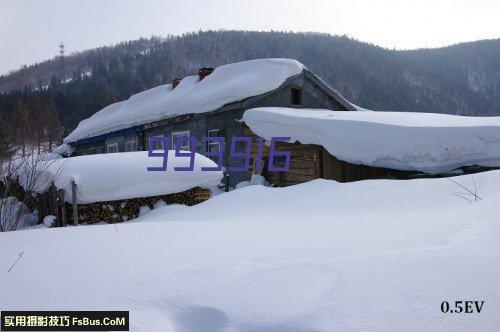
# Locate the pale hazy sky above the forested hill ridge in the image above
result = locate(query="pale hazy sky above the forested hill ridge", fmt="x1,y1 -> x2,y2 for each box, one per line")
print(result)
0,0 -> 500,74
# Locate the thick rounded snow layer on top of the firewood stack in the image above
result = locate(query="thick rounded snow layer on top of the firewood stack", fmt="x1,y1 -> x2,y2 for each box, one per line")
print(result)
11,150 -> 222,204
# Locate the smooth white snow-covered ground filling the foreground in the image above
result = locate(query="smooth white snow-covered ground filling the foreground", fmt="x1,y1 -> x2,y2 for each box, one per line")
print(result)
0,171 -> 500,332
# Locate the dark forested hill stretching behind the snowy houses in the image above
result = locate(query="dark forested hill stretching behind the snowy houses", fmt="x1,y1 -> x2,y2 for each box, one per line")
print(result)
0,31 -> 500,134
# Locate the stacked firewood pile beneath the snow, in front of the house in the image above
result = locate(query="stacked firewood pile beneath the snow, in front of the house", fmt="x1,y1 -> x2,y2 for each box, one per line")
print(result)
65,187 -> 212,224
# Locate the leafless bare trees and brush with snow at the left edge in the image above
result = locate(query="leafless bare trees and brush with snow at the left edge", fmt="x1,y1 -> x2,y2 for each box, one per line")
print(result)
0,102 -> 65,232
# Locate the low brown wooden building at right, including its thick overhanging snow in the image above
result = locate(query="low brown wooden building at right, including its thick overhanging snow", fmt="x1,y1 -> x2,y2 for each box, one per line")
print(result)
243,106 -> 500,186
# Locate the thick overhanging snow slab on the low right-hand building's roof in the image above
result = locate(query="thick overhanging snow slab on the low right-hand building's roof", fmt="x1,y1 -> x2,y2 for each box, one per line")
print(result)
243,107 -> 500,174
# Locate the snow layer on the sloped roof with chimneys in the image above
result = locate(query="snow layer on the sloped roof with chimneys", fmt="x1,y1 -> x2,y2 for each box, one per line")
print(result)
64,59 -> 305,143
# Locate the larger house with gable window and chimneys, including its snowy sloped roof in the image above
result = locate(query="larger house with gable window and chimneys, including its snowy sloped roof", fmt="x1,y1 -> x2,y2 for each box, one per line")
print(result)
64,59 -> 355,186
